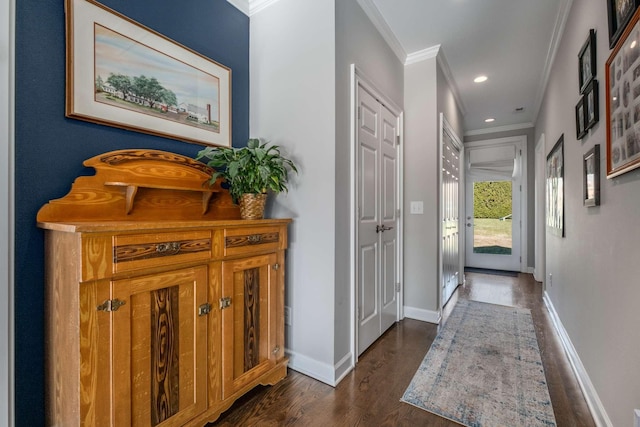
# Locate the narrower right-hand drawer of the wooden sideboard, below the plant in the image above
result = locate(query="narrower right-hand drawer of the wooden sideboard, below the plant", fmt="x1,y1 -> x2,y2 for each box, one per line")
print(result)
224,227 -> 284,256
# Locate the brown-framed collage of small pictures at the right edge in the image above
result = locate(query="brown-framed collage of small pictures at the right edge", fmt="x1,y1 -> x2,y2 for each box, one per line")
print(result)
605,9 -> 640,178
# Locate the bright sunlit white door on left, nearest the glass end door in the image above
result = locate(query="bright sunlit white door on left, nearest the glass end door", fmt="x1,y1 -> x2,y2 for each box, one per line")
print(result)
440,118 -> 461,306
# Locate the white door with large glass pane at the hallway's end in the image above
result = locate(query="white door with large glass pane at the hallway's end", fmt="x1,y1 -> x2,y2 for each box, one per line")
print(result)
465,140 -> 522,271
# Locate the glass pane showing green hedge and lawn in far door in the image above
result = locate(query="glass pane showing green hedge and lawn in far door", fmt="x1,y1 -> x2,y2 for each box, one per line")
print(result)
473,181 -> 512,255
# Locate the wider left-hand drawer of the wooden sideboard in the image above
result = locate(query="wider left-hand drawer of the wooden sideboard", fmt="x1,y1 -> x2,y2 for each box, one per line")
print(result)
113,231 -> 211,273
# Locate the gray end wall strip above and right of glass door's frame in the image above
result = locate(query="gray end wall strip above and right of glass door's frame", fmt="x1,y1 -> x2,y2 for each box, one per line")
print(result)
464,127 -> 538,268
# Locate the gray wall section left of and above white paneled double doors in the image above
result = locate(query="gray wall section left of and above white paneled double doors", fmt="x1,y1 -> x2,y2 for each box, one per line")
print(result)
334,0 -> 404,363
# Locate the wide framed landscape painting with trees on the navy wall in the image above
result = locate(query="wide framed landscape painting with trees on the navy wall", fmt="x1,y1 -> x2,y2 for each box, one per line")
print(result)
65,0 -> 231,147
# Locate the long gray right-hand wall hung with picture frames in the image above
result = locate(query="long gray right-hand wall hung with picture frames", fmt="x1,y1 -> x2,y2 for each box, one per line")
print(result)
535,0 -> 640,426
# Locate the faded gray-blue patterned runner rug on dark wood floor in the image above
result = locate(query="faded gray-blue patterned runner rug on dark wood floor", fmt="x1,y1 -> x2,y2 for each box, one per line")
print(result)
401,300 -> 556,427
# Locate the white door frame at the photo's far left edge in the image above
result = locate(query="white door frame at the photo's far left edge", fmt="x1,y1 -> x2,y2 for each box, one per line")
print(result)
0,0 -> 15,426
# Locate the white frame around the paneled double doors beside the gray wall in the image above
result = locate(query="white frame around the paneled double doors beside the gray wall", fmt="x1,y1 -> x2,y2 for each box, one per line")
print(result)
350,64 -> 404,367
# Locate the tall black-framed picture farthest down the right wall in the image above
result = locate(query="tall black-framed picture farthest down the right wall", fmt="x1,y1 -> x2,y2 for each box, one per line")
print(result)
546,134 -> 565,237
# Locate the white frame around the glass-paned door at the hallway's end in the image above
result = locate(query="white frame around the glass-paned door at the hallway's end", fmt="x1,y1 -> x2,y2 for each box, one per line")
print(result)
464,135 -> 530,273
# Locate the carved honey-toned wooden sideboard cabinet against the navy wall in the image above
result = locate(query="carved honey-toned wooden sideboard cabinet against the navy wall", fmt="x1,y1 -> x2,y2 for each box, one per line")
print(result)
38,150 -> 290,427
